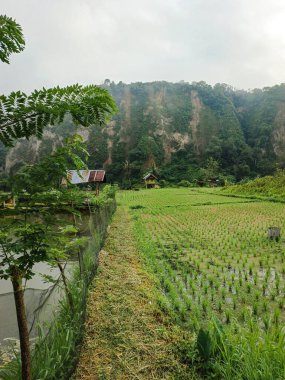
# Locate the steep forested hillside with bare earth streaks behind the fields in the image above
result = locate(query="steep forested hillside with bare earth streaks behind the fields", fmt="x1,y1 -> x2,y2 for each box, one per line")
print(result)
0,80 -> 285,187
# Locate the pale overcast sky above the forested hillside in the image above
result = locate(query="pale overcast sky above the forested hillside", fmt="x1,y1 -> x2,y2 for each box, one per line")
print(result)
0,0 -> 285,94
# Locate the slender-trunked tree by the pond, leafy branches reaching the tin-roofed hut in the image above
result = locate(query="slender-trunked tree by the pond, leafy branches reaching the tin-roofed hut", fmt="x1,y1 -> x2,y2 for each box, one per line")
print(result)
0,136 -> 93,380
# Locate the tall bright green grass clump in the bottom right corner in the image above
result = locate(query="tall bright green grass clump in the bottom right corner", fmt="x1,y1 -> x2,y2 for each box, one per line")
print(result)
202,318 -> 285,380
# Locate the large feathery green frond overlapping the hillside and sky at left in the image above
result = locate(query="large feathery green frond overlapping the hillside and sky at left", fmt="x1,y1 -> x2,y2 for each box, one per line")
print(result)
0,84 -> 116,145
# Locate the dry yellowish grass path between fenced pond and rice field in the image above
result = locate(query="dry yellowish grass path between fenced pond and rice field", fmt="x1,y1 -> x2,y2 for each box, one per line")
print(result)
73,206 -> 191,380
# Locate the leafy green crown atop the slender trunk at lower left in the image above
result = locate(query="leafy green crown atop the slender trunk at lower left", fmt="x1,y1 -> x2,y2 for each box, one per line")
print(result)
0,210 -> 81,281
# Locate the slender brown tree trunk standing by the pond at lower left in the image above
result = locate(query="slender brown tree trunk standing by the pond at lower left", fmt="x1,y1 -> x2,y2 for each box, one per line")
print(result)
11,276 -> 31,380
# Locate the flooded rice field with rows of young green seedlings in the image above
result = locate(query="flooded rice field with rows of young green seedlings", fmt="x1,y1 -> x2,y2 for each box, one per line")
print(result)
118,189 -> 285,379
